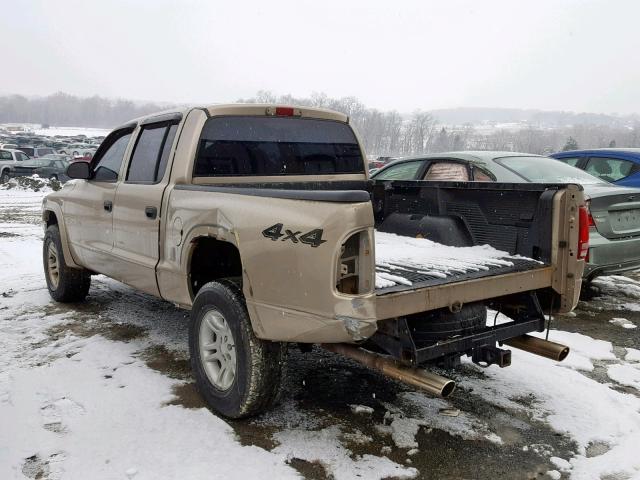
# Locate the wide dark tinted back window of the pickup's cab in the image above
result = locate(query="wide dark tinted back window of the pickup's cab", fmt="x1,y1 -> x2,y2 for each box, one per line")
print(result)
194,117 -> 364,177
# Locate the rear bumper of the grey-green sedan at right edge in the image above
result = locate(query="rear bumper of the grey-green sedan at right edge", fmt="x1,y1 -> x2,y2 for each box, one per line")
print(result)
584,232 -> 640,280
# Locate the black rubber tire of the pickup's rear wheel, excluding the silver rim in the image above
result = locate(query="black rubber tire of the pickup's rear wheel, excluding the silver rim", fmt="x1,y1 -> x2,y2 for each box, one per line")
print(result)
189,279 -> 286,418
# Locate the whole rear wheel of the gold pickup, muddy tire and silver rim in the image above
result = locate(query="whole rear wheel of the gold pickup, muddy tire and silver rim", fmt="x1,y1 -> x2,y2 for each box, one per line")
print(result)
189,280 -> 286,418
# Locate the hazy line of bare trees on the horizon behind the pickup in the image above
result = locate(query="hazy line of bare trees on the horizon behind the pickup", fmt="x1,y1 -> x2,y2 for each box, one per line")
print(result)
0,91 -> 640,156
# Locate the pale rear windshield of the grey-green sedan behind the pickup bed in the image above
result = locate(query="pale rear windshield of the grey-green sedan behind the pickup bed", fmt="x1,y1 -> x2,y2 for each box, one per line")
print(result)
496,157 -> 605,185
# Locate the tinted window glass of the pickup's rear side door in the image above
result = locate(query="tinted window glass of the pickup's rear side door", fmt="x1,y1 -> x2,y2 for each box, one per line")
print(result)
127,124 -> 178,183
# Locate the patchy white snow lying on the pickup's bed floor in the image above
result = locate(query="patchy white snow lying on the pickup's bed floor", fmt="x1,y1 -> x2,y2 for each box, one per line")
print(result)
375,231 -> 542,293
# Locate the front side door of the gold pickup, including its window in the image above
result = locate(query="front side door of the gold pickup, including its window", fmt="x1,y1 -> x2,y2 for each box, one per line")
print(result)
63,126 -> 133,272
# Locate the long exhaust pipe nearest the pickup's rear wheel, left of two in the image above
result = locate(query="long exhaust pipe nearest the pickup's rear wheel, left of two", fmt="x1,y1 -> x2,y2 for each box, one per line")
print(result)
322,343 -> 456,397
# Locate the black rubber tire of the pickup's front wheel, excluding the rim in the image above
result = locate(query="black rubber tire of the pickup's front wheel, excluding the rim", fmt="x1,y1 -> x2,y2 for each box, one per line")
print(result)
42,225 -> 91,303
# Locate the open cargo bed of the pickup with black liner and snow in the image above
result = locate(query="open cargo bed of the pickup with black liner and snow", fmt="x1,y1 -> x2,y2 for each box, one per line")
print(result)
373,181 -> 564,319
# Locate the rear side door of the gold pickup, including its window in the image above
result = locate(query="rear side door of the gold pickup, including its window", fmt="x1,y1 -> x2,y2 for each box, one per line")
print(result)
113,115 -> 181,295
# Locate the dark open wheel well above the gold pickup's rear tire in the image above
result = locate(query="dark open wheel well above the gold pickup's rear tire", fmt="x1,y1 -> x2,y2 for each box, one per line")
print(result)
189,237 -> 242,297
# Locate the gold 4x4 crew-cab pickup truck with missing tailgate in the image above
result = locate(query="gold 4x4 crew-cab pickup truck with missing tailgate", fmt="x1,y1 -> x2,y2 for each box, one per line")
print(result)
43,104 -> 588,418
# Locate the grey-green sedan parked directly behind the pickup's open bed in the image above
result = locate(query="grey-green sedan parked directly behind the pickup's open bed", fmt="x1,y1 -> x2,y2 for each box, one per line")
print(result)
371,152 -> 640,281
